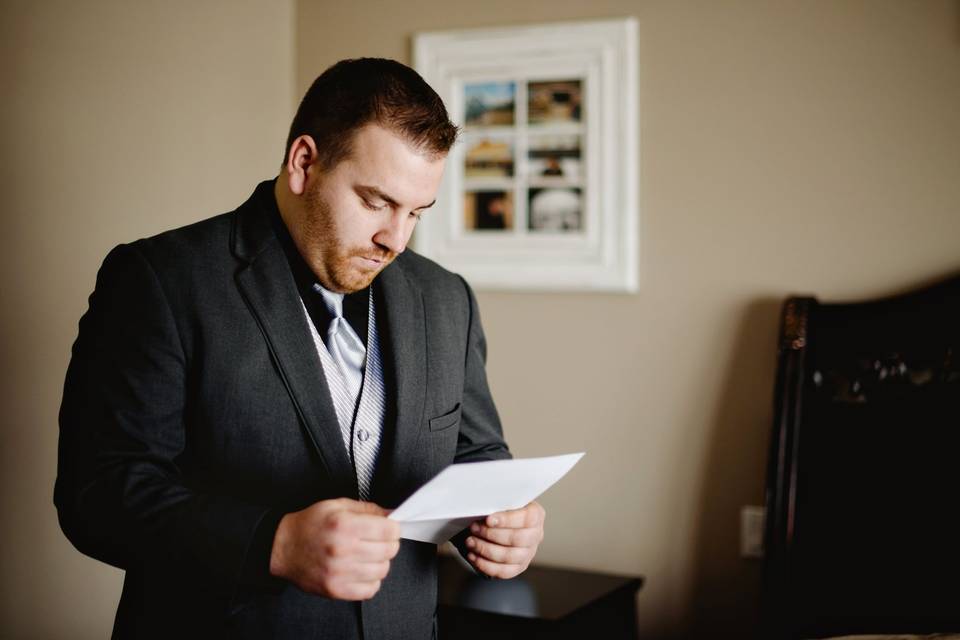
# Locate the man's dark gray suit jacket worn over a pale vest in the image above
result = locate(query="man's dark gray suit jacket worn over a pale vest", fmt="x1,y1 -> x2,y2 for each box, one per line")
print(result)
55,182 -> 510,640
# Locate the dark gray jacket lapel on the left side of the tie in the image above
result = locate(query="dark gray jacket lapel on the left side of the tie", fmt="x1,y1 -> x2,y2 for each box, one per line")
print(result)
233,188 -> 357,498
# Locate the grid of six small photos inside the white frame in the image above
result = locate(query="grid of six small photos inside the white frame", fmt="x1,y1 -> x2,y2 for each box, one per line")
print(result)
462,79 -> 586,233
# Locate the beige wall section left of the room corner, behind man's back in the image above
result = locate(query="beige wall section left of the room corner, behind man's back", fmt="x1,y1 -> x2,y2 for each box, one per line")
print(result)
0,0 -> 294,639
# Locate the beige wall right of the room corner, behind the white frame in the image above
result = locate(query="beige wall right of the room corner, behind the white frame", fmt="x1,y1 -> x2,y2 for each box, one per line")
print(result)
297,0 -> 960,637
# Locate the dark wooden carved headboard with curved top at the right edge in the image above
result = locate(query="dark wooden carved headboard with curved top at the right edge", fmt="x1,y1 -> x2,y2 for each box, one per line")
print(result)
763,277 -> 960,639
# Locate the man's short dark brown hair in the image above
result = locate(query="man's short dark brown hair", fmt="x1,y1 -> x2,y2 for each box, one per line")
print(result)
284,58 -> 457,170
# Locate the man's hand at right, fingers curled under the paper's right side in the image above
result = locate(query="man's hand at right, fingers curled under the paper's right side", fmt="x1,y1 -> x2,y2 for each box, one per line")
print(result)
467,502 -> 547,578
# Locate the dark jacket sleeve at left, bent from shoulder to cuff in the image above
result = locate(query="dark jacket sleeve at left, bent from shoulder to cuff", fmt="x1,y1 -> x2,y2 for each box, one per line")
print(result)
54,244 -> 278,591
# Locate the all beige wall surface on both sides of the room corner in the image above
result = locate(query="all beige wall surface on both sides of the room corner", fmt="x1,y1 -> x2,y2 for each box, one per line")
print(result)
0,0 -> 960,638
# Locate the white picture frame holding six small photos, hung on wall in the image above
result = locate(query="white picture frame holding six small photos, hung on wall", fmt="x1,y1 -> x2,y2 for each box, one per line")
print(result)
414,19 -> 640,292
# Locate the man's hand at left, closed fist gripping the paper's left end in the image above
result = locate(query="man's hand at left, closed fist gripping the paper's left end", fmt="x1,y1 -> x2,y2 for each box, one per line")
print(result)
270,498 -> 400,600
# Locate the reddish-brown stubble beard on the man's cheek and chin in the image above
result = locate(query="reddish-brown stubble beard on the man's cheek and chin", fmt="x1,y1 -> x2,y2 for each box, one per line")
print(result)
303,182 -> 397,293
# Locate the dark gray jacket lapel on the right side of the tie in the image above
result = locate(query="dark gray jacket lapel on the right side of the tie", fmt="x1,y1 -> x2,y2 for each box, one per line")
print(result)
372,261 -> 427,506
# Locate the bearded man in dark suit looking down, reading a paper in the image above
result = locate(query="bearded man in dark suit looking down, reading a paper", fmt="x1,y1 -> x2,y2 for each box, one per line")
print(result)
55,59 -> 544,640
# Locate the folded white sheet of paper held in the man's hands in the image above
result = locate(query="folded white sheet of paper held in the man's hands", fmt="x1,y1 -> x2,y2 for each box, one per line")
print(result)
390,453 -> 583,544
